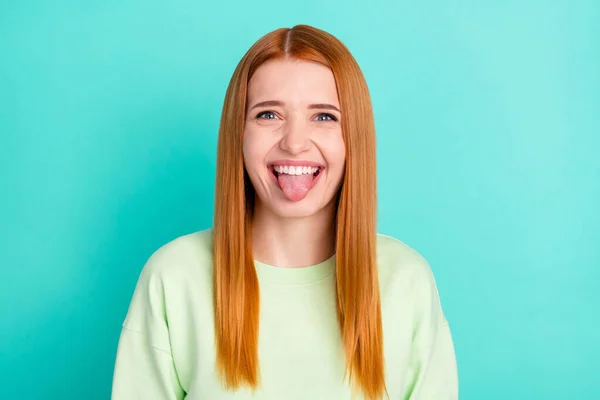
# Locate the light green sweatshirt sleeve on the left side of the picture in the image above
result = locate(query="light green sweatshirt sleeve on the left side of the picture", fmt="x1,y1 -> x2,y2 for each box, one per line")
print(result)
112,253 -> 184,400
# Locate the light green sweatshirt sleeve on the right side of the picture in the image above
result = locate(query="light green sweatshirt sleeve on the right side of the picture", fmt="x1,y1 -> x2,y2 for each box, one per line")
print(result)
403,260 -> 458,400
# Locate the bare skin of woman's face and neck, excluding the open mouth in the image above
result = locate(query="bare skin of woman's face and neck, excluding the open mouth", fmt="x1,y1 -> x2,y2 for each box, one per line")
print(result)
243,60 -> 345,268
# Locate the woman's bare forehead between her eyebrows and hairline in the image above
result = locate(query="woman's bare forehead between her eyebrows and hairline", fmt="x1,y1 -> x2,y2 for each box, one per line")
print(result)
248,60 -> 339,106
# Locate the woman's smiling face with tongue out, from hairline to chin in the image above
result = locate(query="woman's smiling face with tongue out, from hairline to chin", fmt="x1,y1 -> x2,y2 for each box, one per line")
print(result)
243,60 -> 345,217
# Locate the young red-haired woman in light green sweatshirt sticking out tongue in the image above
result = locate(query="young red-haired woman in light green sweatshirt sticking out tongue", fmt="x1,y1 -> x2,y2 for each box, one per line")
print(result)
113,25 -> 458,400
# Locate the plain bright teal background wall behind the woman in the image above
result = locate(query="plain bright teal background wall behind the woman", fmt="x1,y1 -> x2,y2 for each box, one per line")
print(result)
0,0 -> 600,400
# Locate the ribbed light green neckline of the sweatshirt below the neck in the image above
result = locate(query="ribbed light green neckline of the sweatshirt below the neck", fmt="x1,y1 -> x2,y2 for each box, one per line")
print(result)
254,254 -> 335,285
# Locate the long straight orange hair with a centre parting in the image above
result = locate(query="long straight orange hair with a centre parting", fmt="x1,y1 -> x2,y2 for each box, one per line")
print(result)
213,25 -> 387,399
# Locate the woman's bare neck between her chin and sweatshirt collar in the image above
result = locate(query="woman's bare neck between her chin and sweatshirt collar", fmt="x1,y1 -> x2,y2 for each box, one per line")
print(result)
252,201 -> 336,268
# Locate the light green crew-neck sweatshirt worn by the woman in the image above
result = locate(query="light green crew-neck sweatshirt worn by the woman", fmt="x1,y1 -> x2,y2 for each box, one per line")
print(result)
112,229 -> 458,400
